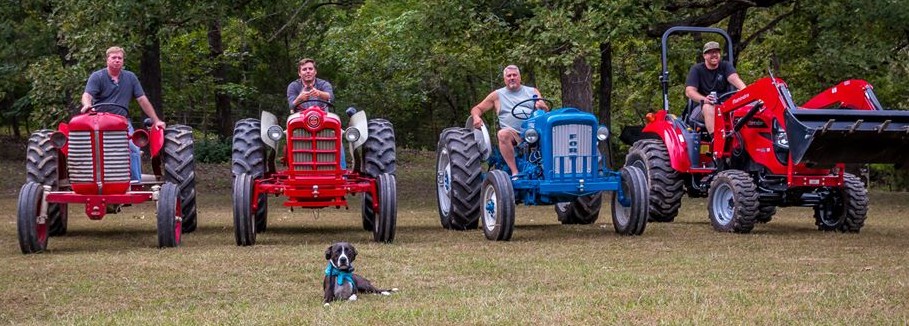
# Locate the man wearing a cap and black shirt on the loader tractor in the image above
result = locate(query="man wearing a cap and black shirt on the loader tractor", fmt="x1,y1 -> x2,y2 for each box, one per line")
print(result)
685,41 -> 745,133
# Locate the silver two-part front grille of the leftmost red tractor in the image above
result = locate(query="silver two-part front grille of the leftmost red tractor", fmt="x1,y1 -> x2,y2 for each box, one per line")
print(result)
66,131 -> 129,183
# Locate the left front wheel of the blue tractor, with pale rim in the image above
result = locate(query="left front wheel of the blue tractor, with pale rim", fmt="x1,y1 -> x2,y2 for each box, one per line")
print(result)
482,170 -> 514,241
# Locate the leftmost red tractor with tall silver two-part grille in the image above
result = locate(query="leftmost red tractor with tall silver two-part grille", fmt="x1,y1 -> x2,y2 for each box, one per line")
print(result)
17,103 -> 196,254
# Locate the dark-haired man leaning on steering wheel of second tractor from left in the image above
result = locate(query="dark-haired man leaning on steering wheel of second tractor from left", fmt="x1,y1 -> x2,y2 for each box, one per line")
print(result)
287,58 -> 335,113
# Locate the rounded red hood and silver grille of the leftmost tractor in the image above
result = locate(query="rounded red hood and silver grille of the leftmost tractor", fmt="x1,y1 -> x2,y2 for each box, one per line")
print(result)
61,113 -> 148,195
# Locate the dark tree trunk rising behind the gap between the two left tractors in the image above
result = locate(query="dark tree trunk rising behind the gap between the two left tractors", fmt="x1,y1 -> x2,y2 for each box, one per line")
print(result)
208,19 -> 233,139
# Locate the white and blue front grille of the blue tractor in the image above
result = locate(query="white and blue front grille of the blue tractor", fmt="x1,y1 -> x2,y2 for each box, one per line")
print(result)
552,124 -> 597,178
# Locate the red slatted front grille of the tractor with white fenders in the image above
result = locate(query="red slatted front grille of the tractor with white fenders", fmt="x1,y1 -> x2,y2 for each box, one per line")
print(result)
291,128 -> 338,171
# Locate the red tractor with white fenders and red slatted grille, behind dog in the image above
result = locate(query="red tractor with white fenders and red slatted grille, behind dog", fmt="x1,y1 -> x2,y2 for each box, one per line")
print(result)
231,100 -> 397,246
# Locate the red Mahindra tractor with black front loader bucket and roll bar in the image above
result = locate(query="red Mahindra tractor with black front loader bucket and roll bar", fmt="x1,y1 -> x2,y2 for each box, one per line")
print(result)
625,27 -> 909,233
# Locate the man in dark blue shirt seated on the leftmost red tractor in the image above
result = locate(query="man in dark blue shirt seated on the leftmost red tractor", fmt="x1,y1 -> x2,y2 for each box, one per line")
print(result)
81,46 -> 166,181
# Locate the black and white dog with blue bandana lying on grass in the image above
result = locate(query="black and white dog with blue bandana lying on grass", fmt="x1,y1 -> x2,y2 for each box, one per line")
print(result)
322,242 -> 398,306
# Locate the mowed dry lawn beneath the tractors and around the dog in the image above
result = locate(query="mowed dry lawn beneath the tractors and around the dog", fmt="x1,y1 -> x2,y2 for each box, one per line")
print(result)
0,151 -> 909,325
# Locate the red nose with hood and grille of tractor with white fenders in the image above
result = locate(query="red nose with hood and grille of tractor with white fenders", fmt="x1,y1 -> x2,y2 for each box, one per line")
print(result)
286,109 -> 342,174
